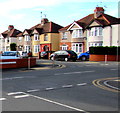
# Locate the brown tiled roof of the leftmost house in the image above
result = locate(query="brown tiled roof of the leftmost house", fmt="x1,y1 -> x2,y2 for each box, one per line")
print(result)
1,29 -> 21,38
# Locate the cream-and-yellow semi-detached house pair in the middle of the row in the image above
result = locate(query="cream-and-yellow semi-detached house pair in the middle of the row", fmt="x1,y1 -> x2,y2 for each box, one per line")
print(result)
18,18 -> 62,56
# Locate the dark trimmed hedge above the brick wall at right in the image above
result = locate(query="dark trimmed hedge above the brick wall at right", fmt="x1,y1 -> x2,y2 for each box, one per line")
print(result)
89,46 -> 120,55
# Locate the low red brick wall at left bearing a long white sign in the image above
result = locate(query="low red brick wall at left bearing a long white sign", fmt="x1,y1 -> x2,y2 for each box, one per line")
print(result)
0,58 -> 36,69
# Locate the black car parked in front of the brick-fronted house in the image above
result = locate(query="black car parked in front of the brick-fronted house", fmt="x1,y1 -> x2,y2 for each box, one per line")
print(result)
50,50 -> 77,61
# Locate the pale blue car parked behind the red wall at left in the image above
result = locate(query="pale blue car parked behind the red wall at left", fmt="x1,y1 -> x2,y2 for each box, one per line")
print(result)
0,51 -> 21,59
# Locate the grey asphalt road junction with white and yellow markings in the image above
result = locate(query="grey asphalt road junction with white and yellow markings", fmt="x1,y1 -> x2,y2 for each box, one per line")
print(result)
0,60 -> 119,113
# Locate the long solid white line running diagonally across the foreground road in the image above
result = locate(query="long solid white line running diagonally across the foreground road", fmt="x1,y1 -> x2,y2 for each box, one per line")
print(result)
24,93 -> 88,113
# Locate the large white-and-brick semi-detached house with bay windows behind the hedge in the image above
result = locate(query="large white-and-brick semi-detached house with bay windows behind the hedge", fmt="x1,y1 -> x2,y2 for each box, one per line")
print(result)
59,7 -> 120,54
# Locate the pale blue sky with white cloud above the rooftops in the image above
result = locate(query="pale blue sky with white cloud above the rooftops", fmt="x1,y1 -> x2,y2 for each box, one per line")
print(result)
0,0 -> 119,33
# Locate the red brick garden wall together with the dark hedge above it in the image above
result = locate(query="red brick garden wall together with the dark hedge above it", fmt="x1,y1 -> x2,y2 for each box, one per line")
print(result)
89,46 -> 120,61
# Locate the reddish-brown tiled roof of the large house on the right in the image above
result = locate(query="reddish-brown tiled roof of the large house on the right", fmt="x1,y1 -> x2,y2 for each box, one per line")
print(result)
59,13 -> 120,31
